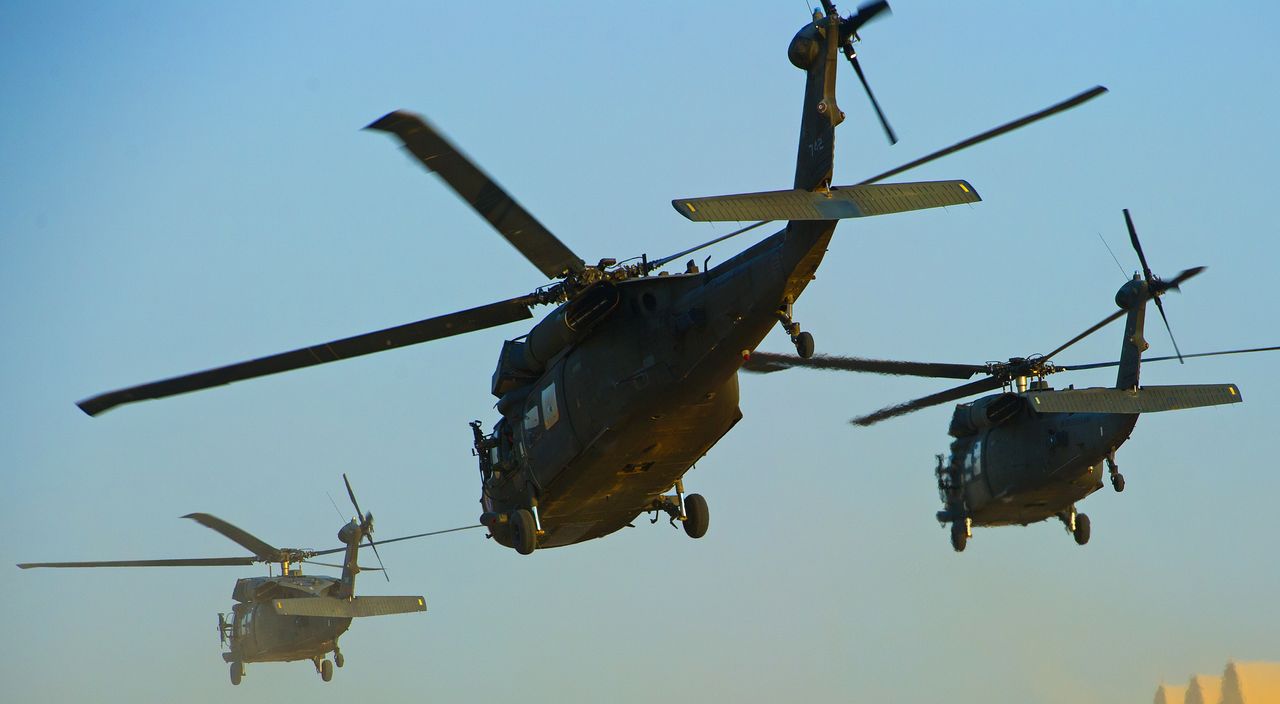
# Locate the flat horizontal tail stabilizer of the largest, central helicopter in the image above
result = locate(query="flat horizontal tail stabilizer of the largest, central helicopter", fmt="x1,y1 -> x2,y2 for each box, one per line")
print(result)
671,180 -> 982,223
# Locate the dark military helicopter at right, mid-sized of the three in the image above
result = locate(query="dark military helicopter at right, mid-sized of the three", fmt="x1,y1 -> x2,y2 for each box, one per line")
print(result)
744,209 -> 1280,552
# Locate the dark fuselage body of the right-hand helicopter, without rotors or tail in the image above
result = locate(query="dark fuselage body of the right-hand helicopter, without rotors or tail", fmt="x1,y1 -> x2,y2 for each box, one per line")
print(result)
938,392 -> 1138,526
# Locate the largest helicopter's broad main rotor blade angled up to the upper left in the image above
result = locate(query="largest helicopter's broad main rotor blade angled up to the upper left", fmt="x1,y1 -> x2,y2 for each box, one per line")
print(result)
365,110 -> 585,279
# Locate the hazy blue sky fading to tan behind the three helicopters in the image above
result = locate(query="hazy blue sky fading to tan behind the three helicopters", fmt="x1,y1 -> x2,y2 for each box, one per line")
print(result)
0,0 -> 1280,704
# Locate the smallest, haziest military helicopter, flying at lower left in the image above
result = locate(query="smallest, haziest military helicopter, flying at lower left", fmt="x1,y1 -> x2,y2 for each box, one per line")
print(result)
18,475 -> 480,685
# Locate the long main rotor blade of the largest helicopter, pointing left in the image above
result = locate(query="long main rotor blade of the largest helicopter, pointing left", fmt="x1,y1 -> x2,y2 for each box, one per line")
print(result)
76,296 -> 536,416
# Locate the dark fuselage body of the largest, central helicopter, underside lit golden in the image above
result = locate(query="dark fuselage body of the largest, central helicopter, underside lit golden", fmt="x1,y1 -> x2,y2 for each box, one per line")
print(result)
481,221 -> 835,548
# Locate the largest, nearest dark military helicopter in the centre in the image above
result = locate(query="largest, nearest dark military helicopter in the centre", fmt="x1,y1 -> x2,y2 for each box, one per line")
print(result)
78,1 -> 1106,554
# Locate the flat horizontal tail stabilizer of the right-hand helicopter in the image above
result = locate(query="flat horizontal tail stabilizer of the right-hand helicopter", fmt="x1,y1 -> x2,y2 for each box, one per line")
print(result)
1027,384 -> 1243,413
